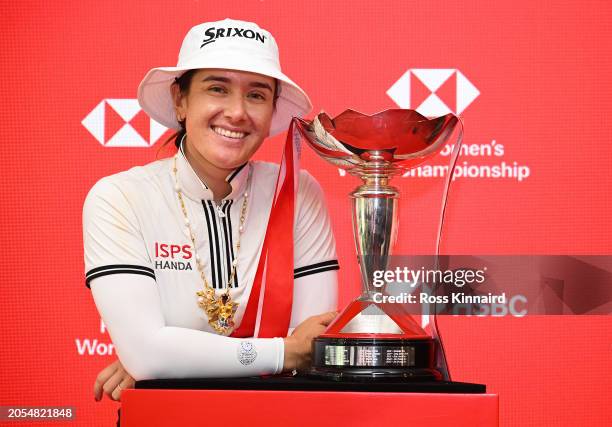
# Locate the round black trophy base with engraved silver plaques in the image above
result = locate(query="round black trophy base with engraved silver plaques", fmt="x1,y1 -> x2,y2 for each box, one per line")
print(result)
308,334 -> 442,382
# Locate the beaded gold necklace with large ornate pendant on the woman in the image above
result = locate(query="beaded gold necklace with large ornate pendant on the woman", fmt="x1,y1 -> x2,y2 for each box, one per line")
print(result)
172,153 -> 252,335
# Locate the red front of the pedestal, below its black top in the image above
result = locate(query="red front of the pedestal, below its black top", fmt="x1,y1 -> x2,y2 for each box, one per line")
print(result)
121,390 -> 499,427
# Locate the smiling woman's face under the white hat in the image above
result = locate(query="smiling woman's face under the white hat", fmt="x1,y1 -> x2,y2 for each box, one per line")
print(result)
173,69 -> 276,176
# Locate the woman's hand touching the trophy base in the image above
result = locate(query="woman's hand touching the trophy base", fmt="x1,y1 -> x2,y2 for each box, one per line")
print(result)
283,311 -> 338,372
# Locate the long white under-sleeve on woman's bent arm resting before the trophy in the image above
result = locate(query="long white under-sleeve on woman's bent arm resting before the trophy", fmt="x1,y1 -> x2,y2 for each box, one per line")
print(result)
90,274 -> 284,380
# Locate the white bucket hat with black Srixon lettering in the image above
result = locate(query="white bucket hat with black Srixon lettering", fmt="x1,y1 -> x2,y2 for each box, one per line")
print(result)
138,19 -> 312,136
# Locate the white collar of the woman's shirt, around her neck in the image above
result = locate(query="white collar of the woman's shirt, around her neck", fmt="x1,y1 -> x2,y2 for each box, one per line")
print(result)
176,137 -> 252,200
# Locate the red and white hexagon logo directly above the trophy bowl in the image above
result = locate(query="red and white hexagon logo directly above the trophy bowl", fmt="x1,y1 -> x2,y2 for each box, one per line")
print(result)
387,68 -> 480,117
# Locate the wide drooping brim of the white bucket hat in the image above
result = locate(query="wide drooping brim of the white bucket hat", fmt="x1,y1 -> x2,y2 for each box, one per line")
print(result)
138,55 -> 312,136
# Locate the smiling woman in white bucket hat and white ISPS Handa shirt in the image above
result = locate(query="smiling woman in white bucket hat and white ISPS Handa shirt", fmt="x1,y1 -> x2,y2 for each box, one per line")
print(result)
83,19 -> 338,399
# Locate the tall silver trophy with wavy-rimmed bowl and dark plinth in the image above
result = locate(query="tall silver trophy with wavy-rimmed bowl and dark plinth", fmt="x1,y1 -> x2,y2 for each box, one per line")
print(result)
297,109 -> 458,381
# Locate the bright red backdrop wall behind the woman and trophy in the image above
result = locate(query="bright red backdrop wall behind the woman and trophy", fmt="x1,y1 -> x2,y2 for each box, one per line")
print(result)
0,0 -> 612,426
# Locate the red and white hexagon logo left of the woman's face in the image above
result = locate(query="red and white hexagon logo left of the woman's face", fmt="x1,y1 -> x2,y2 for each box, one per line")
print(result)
81,99 -> 168,147
